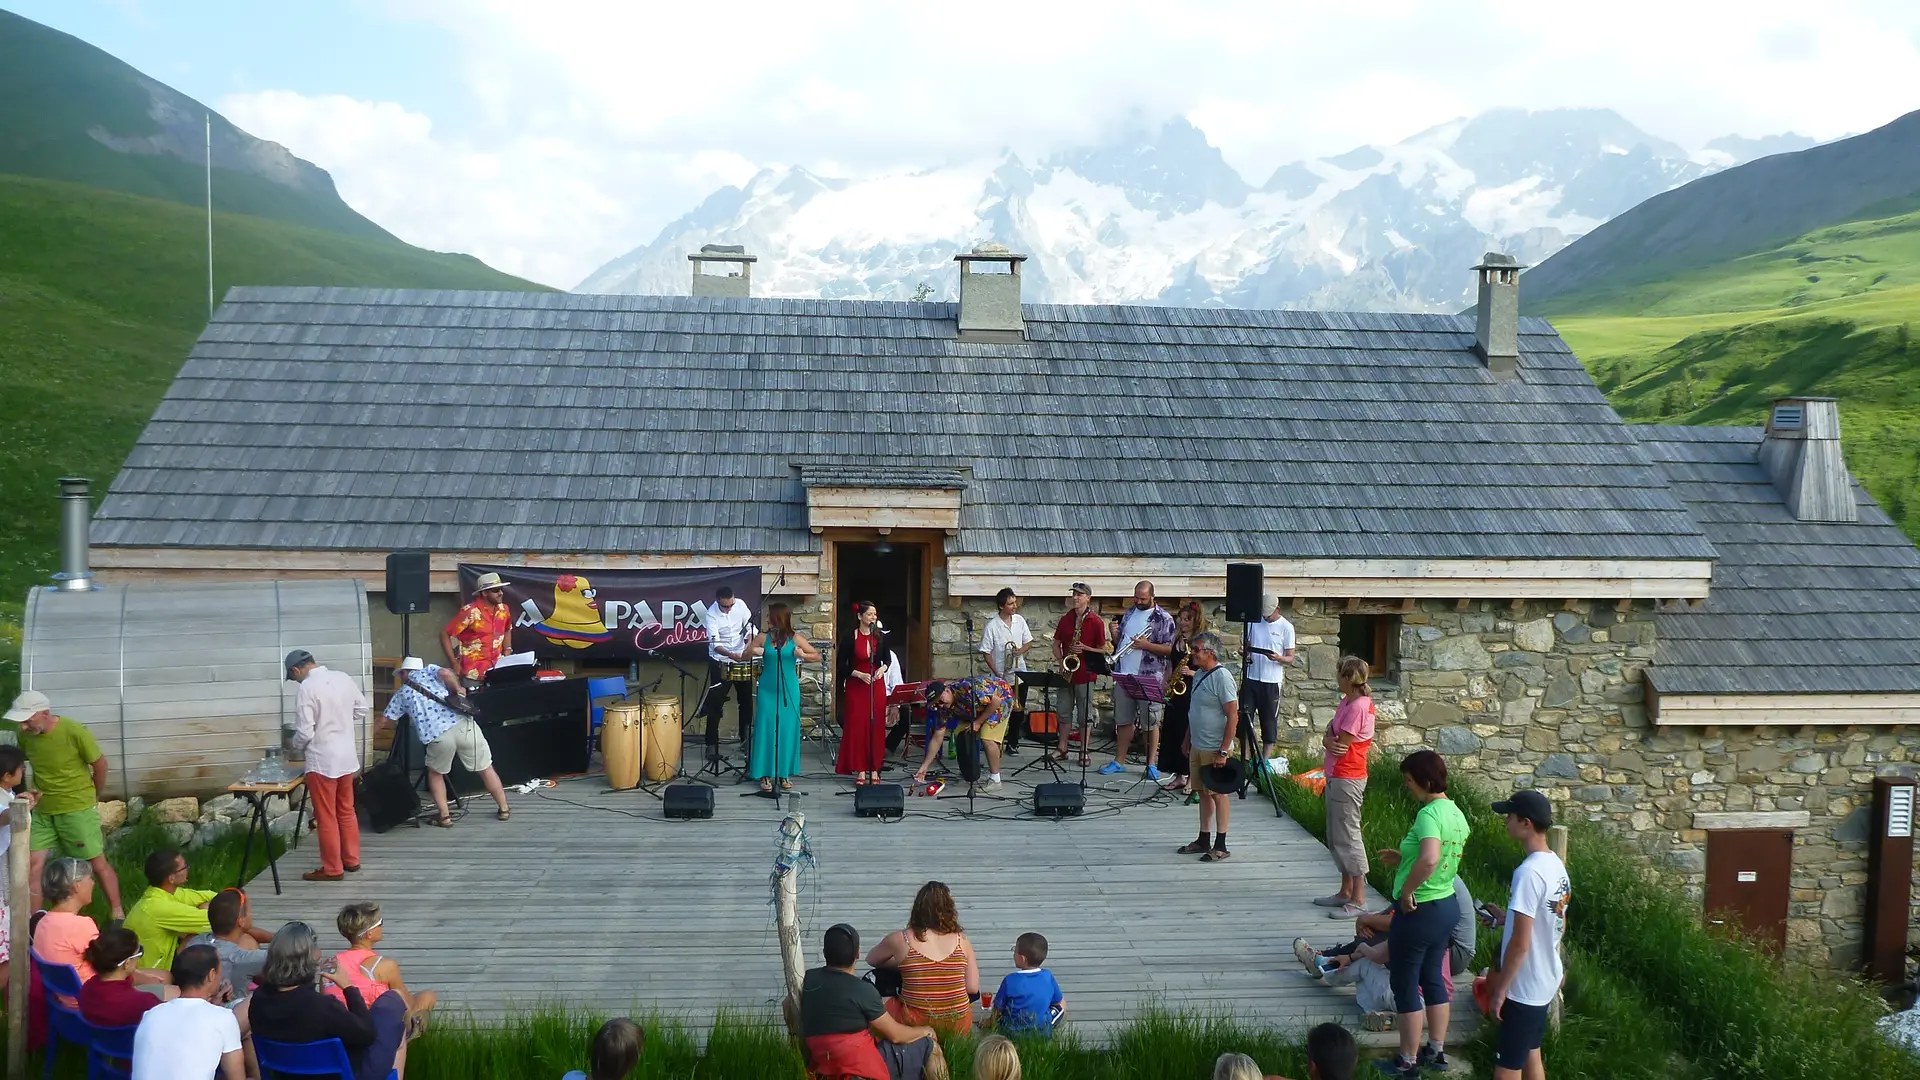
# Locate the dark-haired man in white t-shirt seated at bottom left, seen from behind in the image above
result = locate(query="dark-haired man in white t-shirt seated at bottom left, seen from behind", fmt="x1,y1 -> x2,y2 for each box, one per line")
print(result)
132,945 -> 246,1080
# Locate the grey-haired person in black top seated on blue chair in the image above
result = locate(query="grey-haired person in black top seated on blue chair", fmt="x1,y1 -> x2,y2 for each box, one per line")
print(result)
248,922 -> 403,1080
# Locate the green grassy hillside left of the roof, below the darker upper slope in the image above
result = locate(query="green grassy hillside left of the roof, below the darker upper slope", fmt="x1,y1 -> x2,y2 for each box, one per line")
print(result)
0,175 -> 545,690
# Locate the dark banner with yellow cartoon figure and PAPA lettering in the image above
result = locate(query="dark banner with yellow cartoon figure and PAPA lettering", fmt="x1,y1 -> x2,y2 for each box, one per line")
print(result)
461,563 -> 760,659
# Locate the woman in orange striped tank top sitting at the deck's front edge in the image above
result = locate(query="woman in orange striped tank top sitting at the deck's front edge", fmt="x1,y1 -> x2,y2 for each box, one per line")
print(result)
866,882 -> 979,1034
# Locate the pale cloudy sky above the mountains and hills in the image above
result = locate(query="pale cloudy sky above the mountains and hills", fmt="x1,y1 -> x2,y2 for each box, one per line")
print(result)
0,0 -> 1920,288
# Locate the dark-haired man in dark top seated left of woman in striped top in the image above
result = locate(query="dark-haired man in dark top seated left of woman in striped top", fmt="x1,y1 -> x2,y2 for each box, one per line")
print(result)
799,922 -> 947,1080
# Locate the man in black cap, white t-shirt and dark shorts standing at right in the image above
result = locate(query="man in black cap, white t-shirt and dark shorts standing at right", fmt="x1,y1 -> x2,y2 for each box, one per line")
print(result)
1486,780 -> 1572,1080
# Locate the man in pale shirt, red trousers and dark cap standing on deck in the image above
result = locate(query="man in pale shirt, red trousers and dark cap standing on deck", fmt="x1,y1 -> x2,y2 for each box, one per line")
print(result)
286,650 -> 371,882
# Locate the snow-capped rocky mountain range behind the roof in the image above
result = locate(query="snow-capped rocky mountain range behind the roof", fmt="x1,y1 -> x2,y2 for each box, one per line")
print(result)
578,110 -> 1797,311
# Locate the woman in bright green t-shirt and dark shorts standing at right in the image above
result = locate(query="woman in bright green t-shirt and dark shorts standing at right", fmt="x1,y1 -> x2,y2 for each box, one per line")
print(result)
1379,749 -> 1473,1076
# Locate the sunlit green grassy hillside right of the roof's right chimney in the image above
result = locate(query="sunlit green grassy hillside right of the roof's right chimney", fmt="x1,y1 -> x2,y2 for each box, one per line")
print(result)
1523,200 -> 1920,540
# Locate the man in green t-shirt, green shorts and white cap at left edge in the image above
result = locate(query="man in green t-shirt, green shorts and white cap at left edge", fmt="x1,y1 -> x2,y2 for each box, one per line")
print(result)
6,690 -> 127,922
